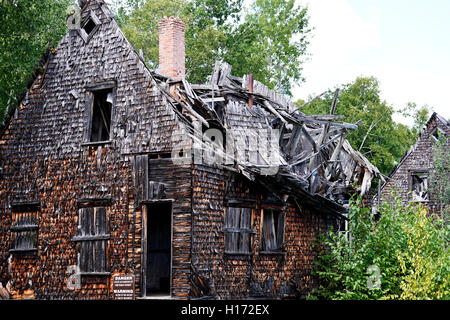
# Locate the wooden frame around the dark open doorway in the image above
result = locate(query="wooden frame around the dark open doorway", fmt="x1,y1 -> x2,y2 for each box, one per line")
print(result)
141,199 -> 174,297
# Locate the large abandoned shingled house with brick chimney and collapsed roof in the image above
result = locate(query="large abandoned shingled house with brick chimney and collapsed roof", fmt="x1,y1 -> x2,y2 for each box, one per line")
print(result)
0,0 -> 380,299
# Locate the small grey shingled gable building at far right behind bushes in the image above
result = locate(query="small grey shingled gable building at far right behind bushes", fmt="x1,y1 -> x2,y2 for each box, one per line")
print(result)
373,112 -> 450,212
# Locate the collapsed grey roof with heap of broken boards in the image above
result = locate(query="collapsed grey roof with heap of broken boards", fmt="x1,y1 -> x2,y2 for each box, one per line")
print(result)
154,62 -> 384,213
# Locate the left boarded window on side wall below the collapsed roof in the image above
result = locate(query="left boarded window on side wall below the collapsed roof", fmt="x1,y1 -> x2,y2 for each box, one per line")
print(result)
224,207 -> 254,254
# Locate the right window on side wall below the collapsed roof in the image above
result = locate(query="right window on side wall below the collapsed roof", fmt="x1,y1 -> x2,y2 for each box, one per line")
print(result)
261,209 -> 284,251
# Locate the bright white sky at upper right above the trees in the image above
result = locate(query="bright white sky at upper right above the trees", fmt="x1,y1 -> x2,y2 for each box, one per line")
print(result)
293,0 -> 450,124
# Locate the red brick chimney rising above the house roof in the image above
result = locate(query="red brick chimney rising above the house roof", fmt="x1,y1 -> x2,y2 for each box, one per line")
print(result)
158,17 -> 186,80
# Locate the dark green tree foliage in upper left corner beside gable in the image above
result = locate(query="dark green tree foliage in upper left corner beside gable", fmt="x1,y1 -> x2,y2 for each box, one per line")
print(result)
0,0 -> 70,122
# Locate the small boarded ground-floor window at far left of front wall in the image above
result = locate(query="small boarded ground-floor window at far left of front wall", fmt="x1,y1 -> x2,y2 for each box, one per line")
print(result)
11,211 -> 39,252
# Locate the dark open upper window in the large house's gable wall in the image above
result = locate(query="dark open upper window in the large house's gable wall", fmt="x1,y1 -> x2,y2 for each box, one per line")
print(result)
90,89 -> 113,142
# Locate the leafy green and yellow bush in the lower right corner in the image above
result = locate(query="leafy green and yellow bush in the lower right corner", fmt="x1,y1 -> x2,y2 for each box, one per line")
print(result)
310,197 -> 450,300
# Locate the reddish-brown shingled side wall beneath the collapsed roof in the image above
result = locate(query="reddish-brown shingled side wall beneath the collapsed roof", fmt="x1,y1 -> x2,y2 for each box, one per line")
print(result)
191,165 -> 334,299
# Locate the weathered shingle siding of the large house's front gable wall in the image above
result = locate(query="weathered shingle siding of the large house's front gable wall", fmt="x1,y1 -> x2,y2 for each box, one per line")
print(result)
0,1 -> 190,299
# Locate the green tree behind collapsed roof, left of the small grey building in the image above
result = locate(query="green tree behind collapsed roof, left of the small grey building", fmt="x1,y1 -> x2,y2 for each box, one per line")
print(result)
297,77 -> 428,175
